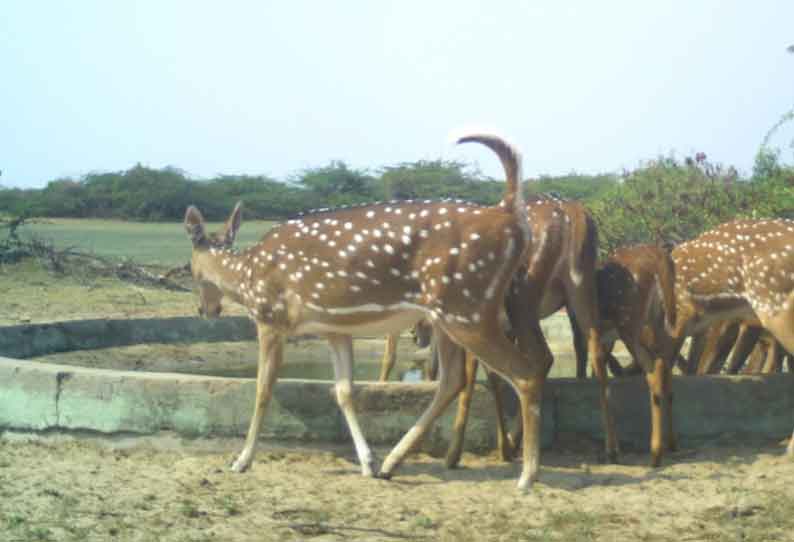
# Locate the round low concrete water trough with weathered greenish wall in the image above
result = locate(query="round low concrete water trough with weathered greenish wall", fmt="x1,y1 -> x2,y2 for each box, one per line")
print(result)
0,317 -> 794,451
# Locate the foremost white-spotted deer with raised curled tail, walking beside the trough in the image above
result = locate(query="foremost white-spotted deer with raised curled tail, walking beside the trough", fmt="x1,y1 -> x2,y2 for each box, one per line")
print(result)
185,134 -> 551,489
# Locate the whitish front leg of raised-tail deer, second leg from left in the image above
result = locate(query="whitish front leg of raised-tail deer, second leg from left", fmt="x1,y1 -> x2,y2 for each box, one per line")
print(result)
328,335 -> 378,476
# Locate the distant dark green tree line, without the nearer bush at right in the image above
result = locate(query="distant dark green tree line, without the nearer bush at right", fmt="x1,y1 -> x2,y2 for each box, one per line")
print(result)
0,160 -> 617,222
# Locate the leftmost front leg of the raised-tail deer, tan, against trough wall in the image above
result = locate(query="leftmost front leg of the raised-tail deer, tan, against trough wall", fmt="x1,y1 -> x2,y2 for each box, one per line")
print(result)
232,322 -> 284,472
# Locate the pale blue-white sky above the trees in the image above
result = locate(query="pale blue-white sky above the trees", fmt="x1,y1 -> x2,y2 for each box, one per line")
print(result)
0,0 -> 794,187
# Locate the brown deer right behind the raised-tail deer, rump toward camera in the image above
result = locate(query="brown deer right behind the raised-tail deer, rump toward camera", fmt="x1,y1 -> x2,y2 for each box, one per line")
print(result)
446,197 -> 618,467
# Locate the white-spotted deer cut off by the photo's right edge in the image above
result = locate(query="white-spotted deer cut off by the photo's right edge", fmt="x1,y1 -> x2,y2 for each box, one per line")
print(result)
672,219 -> 794,455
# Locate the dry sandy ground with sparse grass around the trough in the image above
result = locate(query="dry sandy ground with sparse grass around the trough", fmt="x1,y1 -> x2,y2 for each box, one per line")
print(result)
0,266 -> 794,542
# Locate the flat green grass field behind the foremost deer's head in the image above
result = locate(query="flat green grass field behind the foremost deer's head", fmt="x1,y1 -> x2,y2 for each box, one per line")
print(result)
20,218 -> 274,266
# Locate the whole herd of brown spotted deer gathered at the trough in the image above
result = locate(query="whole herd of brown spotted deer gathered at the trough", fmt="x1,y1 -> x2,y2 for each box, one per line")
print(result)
185,133 -> 794,490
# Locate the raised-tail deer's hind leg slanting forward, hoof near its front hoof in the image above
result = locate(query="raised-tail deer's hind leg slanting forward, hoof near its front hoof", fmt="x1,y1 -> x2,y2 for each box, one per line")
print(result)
378,328 -> 465,478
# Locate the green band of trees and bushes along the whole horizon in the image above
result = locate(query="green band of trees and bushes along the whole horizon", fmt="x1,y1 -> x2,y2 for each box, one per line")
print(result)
0,146 -> 794,255
